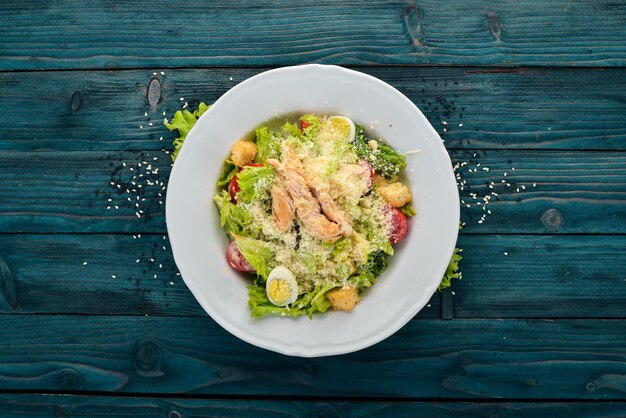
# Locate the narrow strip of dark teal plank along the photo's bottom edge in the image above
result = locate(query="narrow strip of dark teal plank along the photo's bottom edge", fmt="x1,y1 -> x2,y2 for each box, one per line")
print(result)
0,394 -> 626,418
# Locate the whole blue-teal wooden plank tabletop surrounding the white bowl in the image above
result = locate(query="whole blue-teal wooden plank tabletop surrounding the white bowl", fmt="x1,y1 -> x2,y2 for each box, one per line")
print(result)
0,0 -> 626,418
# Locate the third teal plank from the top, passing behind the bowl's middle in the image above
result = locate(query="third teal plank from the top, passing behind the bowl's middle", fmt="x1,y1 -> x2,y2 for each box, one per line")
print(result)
0,150 -> 626,233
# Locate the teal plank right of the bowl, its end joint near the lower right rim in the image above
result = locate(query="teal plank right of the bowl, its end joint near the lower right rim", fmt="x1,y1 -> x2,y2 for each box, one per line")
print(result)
454,235 -> 626,318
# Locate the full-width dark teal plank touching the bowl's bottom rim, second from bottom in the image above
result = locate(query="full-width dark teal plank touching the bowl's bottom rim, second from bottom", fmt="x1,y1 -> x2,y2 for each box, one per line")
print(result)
0,316 -> 626,399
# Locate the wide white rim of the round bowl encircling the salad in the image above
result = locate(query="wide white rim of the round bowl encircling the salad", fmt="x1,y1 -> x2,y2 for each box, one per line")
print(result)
166,65 -> 459,357
